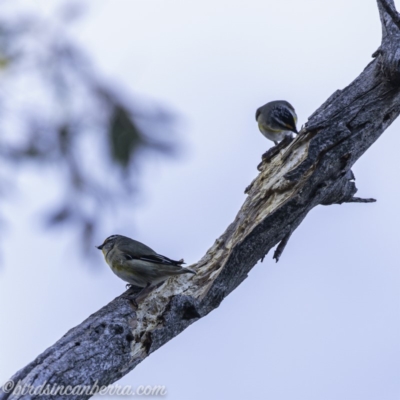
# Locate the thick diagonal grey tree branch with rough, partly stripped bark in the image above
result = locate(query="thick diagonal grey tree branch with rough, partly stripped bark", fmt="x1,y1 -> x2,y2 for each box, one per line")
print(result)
0,0 -> 400,400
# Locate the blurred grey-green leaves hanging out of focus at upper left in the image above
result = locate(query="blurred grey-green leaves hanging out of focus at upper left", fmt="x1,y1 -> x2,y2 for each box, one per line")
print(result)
0,0 -> 175,253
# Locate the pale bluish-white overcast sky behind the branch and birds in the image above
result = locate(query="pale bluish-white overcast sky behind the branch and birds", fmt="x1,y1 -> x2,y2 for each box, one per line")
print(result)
0,0 -> 400,400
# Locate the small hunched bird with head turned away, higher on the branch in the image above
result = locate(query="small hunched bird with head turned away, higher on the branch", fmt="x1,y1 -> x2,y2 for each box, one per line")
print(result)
256,100 -> 297,145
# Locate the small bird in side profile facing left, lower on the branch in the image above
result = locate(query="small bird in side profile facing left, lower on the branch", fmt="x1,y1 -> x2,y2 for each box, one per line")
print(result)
96,235 -> 196,305
